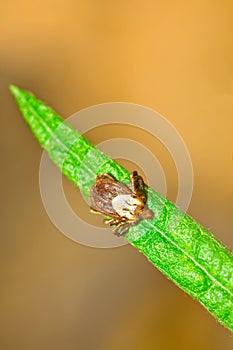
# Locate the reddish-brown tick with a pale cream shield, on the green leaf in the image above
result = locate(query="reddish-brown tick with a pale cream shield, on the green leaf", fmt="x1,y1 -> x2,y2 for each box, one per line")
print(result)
90,171 -> 154,236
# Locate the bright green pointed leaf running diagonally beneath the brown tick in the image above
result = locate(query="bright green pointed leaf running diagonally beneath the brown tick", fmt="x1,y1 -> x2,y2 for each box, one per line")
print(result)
10,86 -> 233,330
